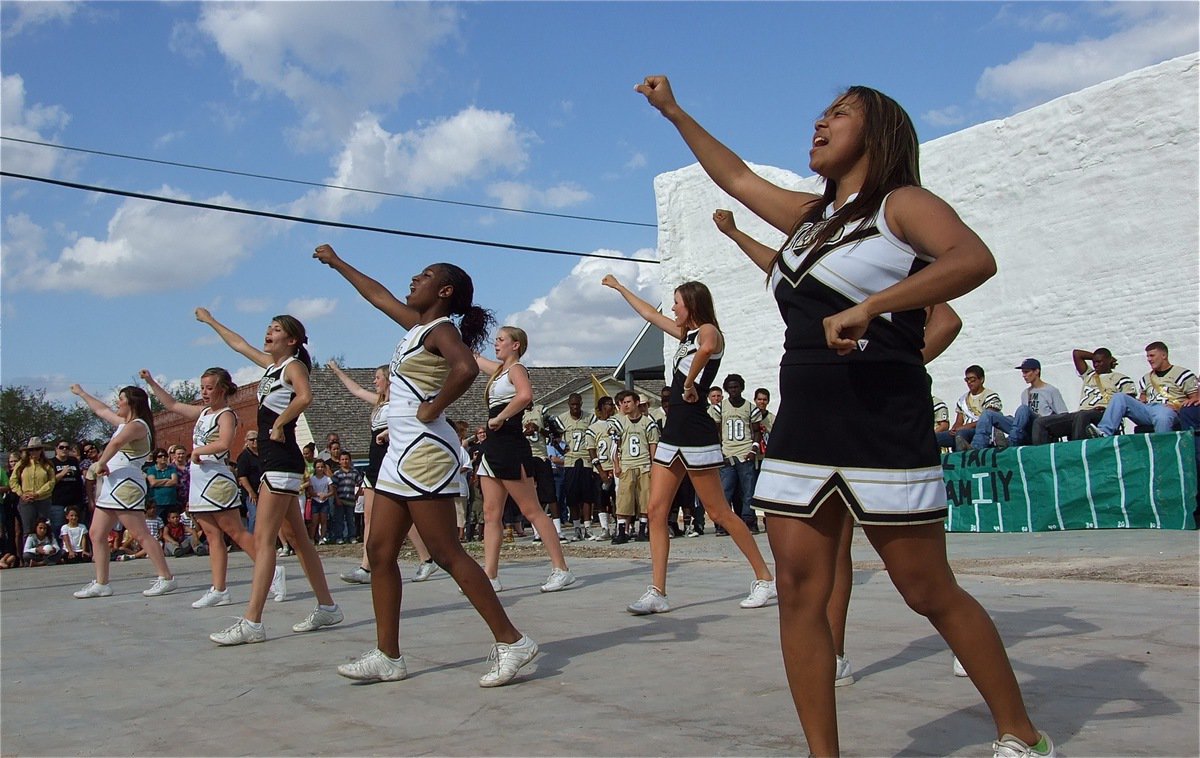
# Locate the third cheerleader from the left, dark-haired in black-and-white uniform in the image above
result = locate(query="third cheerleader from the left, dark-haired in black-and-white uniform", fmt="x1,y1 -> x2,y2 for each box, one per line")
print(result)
196,308 -> 343,645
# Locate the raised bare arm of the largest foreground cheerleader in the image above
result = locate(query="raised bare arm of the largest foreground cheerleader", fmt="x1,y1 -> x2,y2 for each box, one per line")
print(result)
634,76 -> 821,234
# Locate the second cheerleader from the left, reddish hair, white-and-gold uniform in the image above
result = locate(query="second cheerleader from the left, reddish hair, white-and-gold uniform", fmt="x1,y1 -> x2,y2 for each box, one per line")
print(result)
139,367 -> 287,608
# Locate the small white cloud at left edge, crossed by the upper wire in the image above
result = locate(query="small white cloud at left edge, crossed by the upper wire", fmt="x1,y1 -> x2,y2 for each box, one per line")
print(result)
0,72 -> 71,176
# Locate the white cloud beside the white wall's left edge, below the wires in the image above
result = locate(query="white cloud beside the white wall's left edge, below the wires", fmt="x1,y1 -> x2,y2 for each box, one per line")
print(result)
504,249 -> 662,366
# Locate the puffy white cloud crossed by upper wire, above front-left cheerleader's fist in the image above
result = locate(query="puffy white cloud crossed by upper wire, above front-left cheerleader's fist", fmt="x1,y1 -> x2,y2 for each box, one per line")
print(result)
293,108 -> 535,218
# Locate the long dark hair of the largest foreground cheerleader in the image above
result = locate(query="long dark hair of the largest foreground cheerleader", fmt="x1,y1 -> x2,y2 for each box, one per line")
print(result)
767,85 -> 920,275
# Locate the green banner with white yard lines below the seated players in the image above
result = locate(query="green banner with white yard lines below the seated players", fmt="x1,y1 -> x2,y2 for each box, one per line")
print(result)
942,432 -> 1196,531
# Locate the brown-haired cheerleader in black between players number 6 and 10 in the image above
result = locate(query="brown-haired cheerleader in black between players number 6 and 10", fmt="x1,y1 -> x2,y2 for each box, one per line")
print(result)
601,273 -> 775,615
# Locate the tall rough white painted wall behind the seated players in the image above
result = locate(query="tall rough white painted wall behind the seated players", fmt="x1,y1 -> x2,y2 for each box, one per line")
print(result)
654,54 -> 1200,420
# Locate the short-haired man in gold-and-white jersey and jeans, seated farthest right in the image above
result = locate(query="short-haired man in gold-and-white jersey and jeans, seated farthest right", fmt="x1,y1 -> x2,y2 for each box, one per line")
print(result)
1087,342 -> 1200,437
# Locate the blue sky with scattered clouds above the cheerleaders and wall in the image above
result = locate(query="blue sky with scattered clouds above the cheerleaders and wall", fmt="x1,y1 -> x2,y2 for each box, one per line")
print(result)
0,1 -> 1198,398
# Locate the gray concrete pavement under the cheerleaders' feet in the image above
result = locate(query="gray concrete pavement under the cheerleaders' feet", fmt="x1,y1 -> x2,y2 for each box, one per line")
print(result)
0,531 -> 1200,756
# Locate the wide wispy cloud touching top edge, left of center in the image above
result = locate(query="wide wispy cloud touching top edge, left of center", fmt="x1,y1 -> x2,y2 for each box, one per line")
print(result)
197,2 -> 458,144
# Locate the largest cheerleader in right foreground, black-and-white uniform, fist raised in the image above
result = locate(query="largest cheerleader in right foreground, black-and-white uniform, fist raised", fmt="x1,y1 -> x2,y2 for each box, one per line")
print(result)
636,77 -> 1055,758
